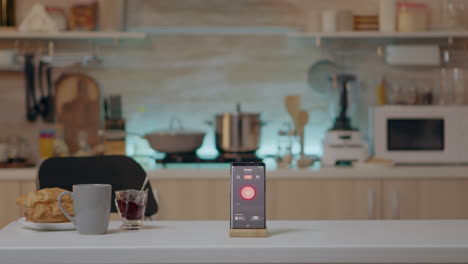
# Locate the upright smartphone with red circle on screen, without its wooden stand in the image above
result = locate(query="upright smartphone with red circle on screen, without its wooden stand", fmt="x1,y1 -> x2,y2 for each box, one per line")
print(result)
231,162 -> 266,229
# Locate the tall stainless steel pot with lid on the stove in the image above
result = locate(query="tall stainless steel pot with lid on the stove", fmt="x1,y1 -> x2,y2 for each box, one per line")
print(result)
215,104 -> 262,153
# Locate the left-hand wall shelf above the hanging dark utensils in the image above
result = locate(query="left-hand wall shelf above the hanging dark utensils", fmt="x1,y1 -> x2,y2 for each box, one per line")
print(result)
0,30 -> 147,40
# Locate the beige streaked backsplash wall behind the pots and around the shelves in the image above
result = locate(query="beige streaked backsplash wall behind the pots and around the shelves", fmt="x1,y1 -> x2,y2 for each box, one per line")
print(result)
0,0 -> 462,164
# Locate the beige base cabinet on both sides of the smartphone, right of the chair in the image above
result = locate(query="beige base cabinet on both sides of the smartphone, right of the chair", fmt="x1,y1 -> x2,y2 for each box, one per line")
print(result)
152,179 -> 381,220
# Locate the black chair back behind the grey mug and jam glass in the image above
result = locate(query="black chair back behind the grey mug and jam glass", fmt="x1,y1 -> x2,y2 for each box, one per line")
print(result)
37,156 -> 158,217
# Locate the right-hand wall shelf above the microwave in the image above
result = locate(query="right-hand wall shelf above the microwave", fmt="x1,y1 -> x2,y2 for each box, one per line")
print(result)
289,31 -> 468,39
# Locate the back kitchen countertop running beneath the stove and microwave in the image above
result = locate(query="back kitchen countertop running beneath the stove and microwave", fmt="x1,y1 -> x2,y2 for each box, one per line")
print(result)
0,165 -> 468,181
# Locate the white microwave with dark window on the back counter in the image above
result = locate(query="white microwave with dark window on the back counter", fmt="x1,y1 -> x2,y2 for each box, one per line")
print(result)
370,105 -> 468,164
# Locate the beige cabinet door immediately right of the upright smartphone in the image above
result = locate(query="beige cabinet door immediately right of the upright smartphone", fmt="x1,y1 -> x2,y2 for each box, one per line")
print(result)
267,179 -> 381,220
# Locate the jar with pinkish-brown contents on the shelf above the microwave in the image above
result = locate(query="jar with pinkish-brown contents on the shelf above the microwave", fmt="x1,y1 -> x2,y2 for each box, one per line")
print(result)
397,3 -> 429,32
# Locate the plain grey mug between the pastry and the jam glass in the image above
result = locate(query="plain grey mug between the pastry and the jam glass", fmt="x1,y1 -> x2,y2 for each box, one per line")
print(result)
57,184 -> 112,235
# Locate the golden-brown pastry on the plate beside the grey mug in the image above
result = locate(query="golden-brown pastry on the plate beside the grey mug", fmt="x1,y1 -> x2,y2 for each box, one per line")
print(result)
16,188 -> 73,223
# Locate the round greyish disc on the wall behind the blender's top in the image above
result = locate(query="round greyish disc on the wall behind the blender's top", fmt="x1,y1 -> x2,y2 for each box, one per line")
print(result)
307,59 -> 342,99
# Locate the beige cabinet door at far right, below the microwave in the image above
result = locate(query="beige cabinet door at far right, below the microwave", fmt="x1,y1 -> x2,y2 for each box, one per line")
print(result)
384,179 -> 468,220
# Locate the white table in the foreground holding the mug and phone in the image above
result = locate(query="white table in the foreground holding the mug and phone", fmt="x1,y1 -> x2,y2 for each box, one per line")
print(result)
0,221 -> 468,264
